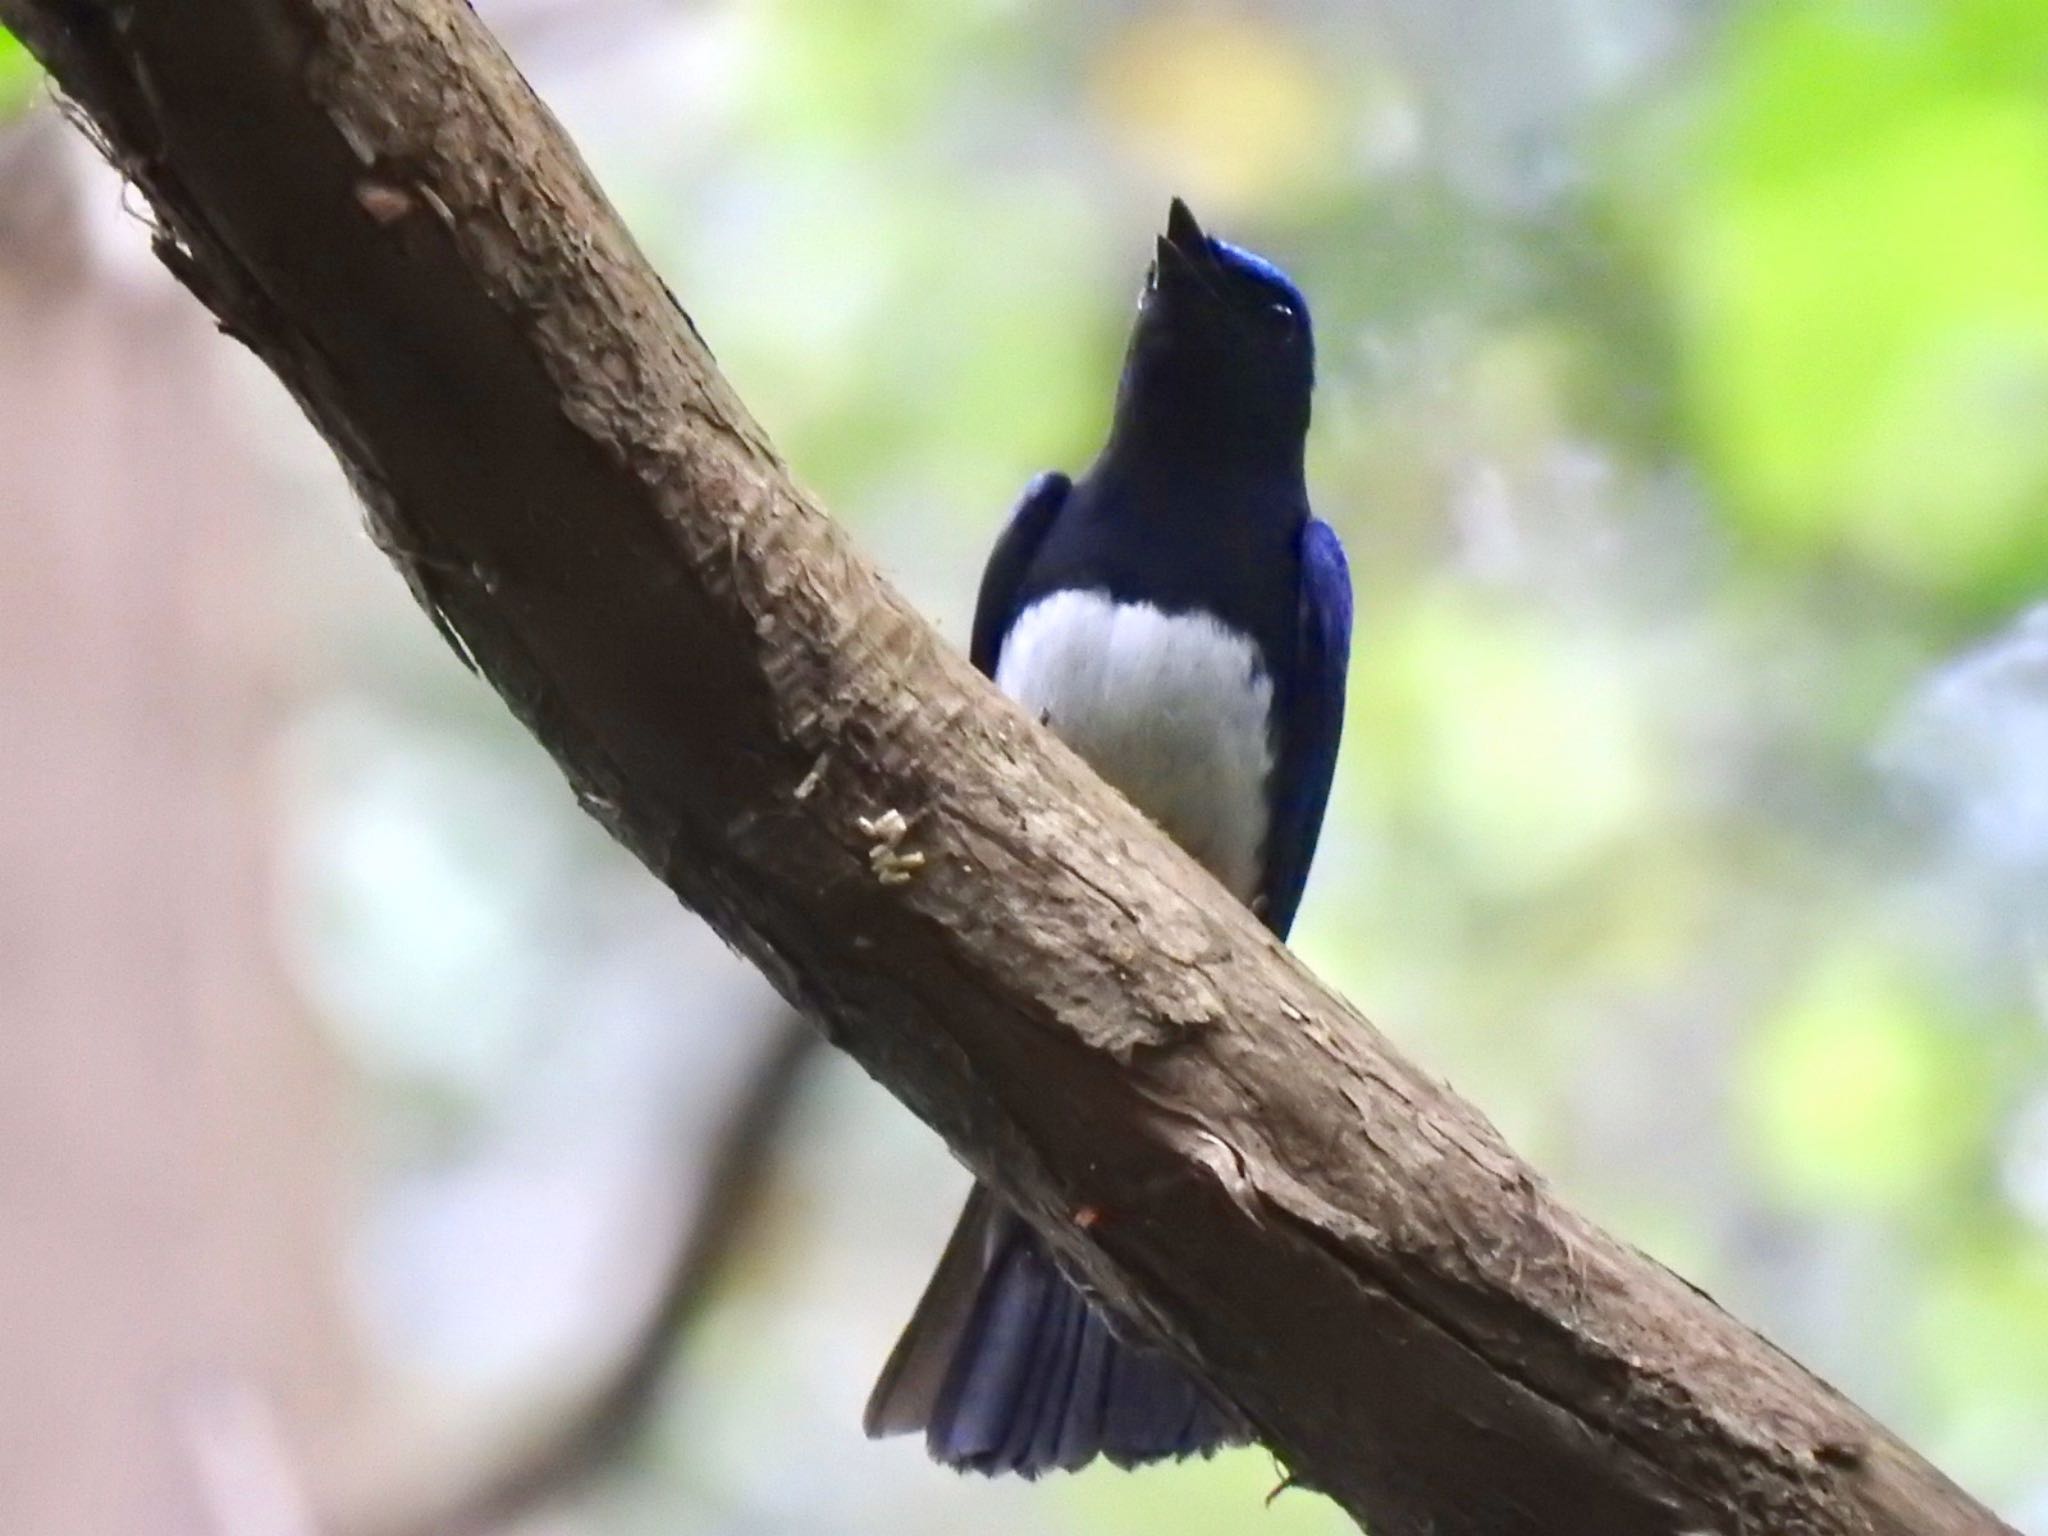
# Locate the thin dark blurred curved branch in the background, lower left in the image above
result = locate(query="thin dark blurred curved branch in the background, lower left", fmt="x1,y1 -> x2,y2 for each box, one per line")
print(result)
375,1008 -> 823,1536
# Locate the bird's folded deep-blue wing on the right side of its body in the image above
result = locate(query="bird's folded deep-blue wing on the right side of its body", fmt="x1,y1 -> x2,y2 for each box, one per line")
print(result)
1260,518 -> 1352,938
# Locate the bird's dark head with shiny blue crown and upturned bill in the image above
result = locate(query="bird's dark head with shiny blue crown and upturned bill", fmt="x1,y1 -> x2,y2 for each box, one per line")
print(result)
1116,197 -> 1315,455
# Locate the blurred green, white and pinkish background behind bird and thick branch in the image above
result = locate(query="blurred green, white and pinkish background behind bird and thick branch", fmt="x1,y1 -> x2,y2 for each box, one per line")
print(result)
0,0 -> 2048,1536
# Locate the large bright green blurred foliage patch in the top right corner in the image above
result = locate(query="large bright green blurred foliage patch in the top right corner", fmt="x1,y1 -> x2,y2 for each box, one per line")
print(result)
1661,0 -> 2048,614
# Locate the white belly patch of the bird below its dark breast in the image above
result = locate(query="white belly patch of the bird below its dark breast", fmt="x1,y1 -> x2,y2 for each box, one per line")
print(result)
995,592 -> 1274,901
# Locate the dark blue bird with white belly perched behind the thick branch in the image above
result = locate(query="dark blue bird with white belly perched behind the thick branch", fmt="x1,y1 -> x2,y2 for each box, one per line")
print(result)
866,199 -> 1352,1477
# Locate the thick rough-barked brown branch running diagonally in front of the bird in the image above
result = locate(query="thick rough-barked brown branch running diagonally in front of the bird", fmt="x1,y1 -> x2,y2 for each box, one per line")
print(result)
0,0 -> 2005,1536
